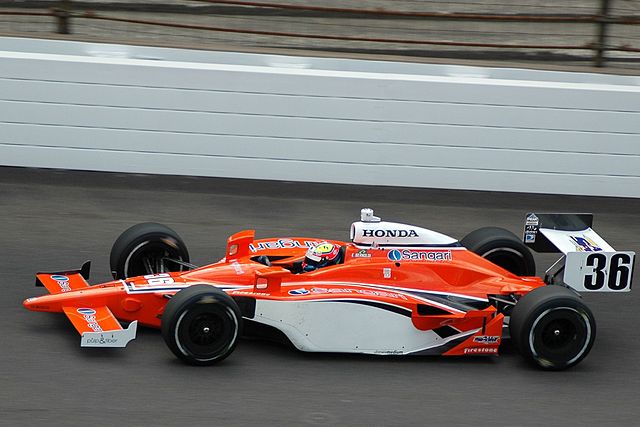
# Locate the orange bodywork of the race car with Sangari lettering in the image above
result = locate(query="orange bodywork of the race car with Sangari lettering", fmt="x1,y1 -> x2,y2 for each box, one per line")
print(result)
24,231 -> 545,355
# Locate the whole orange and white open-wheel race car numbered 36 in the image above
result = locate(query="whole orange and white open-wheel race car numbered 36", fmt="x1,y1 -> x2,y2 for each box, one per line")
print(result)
24,209 -> 635,370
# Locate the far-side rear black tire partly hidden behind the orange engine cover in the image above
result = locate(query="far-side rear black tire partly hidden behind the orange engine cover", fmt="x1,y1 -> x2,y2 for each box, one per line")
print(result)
460,227 -> 536,276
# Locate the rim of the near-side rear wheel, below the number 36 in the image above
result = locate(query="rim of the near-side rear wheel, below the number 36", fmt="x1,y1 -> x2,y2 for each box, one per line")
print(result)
529,307 -> 591,367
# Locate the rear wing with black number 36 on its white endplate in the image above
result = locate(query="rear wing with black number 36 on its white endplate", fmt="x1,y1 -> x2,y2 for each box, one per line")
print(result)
523,213 -> 635,292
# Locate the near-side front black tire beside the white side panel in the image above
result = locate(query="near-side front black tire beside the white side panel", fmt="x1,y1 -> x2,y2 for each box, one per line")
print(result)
161,285 -> 242,366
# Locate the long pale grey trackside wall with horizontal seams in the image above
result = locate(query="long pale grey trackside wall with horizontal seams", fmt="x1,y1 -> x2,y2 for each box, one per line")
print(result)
0,38 -> 640,197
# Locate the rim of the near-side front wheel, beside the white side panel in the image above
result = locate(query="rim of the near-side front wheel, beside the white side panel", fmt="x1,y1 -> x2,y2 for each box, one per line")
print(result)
175,303 -> 238,362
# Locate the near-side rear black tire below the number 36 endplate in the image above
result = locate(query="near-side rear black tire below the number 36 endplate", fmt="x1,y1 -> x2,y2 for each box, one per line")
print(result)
509,285 -> 596,371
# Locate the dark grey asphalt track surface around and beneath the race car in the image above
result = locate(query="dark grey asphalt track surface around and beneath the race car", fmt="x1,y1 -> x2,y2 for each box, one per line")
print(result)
0,168 -> 640,426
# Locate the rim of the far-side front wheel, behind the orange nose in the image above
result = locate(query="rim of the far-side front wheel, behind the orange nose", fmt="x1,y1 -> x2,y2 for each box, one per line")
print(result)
124,240 -> 184,277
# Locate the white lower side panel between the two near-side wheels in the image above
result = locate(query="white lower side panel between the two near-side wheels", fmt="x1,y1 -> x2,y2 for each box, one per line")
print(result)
252,299 -> 477,354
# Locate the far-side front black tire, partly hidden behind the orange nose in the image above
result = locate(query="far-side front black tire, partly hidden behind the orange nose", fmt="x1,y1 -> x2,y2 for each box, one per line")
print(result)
109,222 -> 189,279
